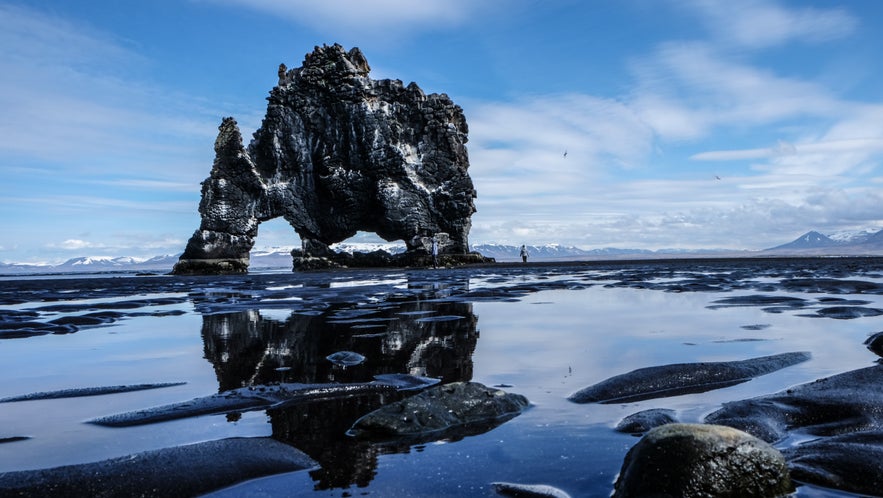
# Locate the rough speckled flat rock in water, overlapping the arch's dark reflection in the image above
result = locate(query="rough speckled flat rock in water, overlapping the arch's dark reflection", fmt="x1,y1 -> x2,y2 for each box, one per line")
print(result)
349,382 -> 528,439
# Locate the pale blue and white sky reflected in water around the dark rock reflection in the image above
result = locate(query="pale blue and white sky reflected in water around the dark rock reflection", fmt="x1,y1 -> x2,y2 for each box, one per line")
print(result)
0,269 -> 883,496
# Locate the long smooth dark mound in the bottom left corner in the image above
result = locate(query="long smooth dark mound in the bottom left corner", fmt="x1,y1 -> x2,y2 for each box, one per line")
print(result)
0,438 -> 317,498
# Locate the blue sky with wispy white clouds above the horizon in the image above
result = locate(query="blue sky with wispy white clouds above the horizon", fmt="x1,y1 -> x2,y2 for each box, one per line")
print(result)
0,0 -> 883,262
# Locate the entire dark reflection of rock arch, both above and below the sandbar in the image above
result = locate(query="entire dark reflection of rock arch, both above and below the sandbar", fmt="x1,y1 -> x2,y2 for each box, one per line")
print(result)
202,301 -> 478,489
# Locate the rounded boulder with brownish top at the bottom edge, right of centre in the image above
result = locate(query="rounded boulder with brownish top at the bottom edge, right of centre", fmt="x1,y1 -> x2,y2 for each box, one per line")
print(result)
613,424 -> 794,498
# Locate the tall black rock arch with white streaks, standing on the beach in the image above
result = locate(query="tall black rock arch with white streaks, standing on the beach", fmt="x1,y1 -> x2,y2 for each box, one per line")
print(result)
174,44 -> 486,273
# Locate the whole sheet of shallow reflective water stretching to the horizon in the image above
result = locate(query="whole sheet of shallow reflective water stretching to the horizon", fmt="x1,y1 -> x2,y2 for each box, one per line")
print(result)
0,259 -> 883,496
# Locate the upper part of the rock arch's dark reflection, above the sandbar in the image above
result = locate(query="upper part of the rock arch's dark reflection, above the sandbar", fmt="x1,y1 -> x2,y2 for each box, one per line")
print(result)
202,302 -> 478,391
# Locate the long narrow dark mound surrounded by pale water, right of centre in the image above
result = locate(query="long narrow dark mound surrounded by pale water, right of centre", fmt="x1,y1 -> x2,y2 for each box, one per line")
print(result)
568,352 -> 811,403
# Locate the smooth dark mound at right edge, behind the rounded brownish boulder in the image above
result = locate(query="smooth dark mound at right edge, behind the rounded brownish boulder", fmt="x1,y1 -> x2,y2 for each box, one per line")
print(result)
705,365 -> 883,442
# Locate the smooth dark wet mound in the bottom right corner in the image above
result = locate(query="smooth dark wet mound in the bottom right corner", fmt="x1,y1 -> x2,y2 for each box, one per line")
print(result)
784,431 -> 883,495
